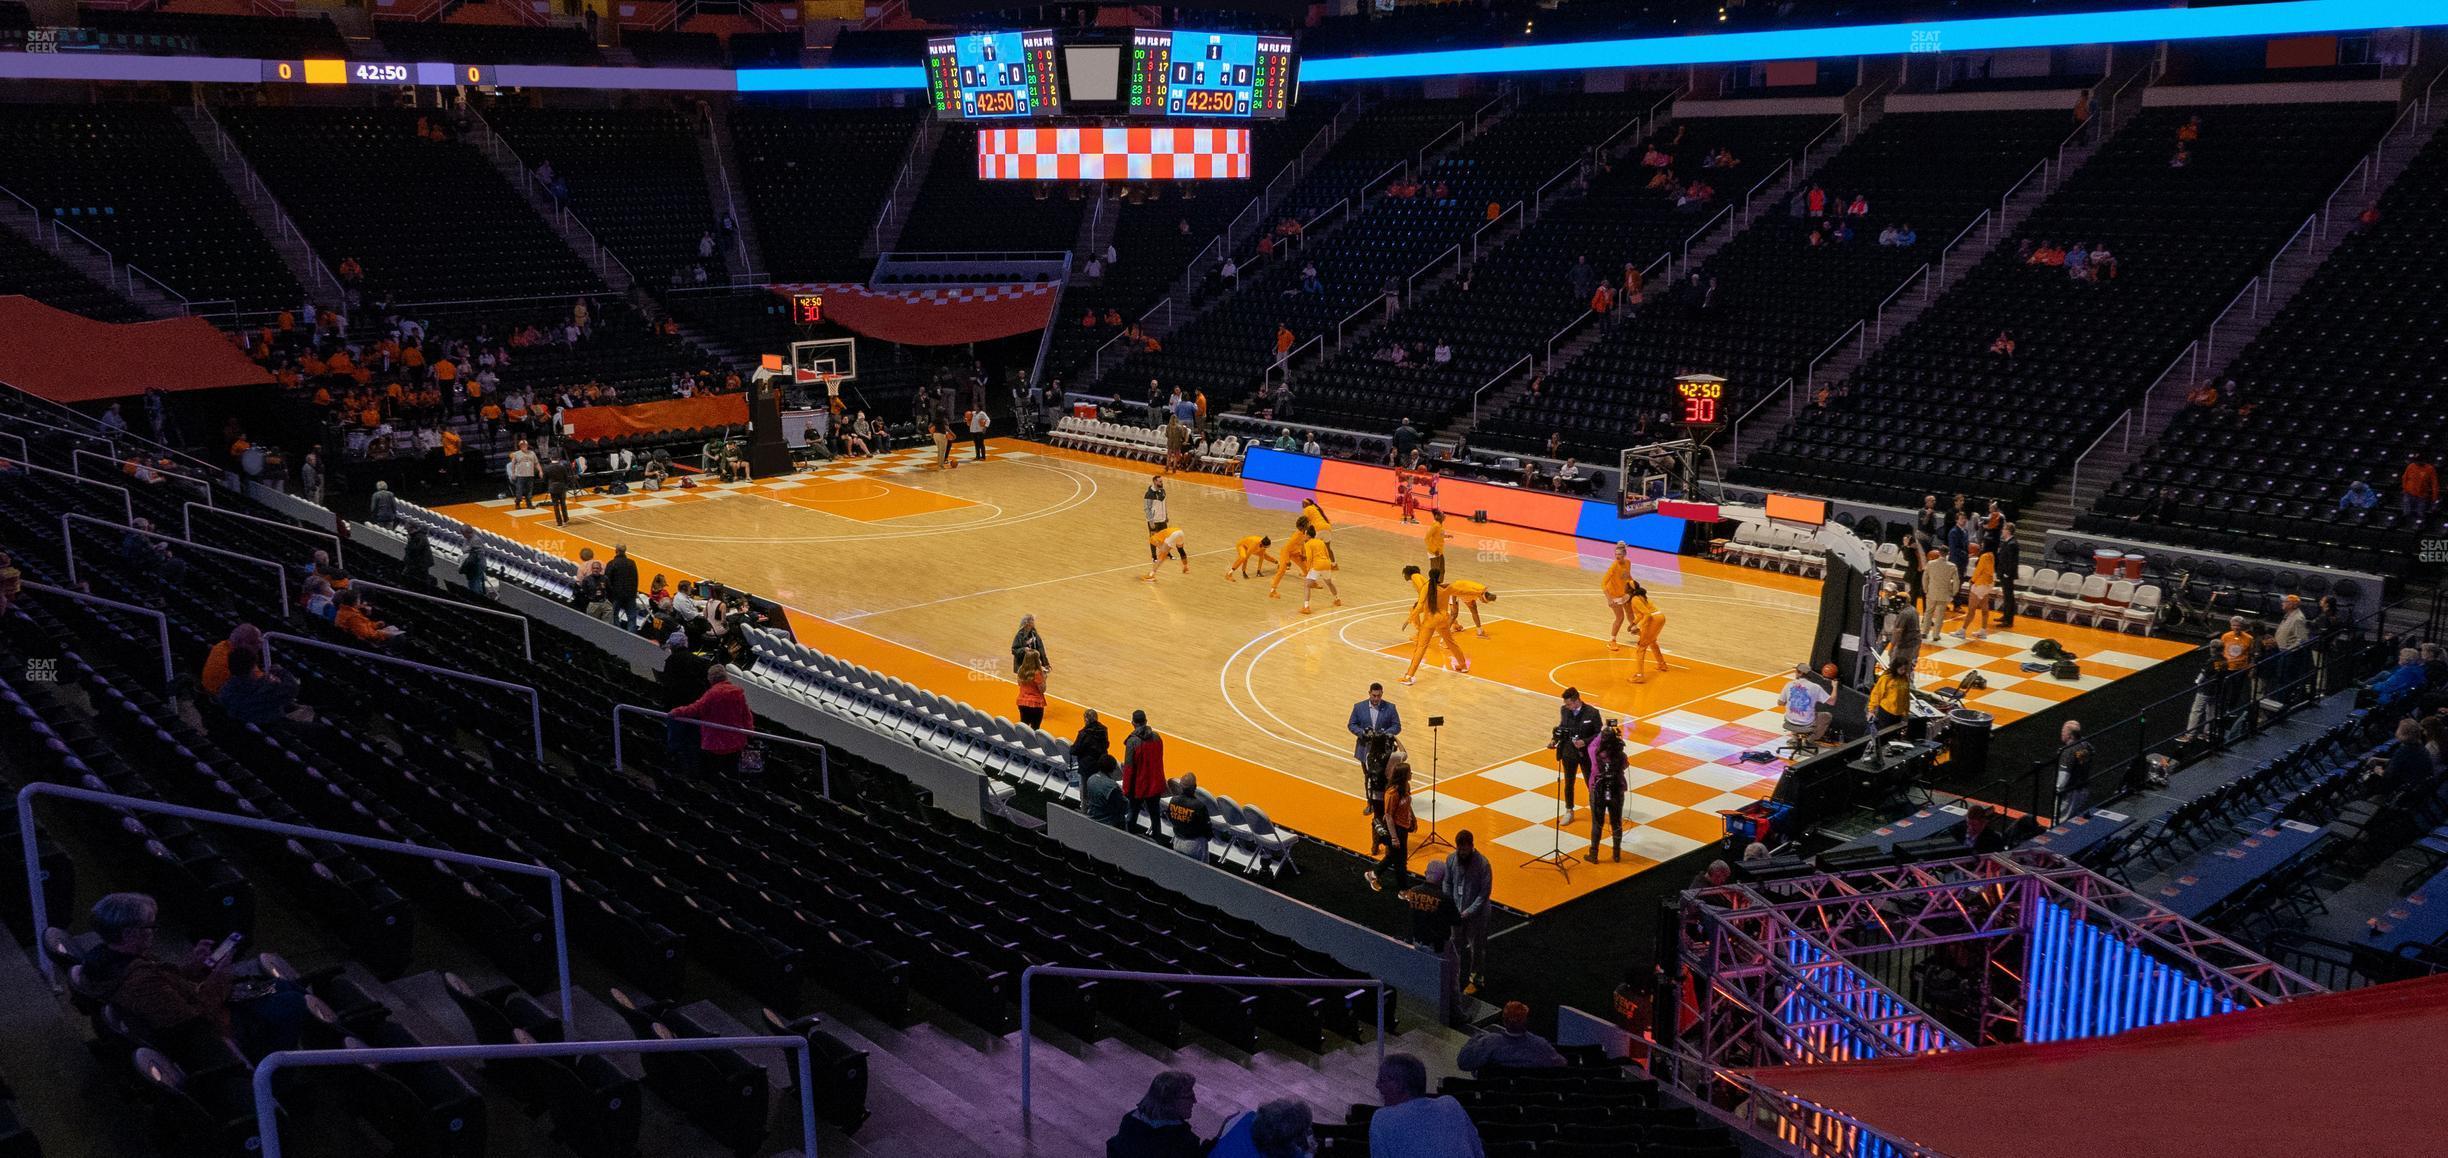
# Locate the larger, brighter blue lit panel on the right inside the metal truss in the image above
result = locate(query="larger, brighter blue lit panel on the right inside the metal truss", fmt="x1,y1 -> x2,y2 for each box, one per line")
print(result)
2022,901 -> 2240,1040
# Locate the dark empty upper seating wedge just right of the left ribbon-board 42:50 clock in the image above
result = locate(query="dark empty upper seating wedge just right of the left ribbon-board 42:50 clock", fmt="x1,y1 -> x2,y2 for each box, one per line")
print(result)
485,108 -> 730,284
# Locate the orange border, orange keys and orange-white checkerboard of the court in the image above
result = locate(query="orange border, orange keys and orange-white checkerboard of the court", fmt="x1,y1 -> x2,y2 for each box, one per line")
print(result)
443,441 -> 2186,913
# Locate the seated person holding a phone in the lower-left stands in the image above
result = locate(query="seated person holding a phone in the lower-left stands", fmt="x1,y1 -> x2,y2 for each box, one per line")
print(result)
78,894 -> 306,1058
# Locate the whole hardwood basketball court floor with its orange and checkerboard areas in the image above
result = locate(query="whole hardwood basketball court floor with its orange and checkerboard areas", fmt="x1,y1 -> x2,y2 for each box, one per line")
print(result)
448,441 -> 2184,911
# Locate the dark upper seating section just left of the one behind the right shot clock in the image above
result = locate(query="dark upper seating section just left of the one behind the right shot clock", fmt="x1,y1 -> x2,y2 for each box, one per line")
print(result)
1361,110 -> 1834,443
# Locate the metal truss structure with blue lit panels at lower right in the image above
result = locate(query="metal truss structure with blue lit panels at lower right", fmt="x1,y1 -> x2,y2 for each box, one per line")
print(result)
1670,850 -> 2323,1067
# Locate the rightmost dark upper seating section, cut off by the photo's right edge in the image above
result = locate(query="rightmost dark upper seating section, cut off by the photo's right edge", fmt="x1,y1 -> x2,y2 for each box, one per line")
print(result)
2078,123 -> 2448,573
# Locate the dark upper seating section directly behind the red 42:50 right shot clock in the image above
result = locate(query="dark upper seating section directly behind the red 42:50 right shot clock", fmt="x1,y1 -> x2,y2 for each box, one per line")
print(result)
1476,113 -> 2066,460
